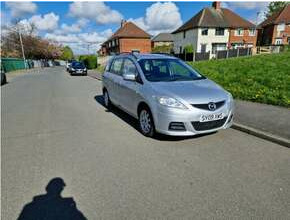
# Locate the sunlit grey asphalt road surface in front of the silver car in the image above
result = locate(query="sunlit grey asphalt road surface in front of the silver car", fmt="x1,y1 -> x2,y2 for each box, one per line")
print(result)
1,67 -> 290,220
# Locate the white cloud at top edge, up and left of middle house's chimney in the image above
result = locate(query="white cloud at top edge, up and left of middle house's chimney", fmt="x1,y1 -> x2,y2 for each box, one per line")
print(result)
69,2 -> 123,24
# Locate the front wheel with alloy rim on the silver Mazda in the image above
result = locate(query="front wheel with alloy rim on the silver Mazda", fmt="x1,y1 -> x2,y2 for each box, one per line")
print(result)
139,108 -> 155,137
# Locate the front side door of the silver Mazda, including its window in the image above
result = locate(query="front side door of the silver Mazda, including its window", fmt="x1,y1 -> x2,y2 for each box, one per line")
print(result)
119,58 -> 142,115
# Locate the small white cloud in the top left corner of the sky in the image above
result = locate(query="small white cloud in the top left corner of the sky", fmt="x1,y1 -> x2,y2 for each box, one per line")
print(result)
6,2 -> 37,18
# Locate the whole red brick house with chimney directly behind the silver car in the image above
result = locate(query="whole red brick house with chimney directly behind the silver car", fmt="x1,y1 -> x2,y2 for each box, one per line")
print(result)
100,21 -> 151,55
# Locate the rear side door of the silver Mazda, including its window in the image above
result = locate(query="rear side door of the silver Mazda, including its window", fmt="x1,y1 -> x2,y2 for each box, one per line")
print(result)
106,58 -> 123,105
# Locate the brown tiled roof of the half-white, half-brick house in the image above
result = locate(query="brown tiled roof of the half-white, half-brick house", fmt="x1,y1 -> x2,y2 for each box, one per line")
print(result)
173,7 -> 255,34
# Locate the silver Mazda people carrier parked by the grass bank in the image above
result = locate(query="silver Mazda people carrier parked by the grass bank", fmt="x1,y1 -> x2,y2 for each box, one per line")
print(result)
103,53 -> 234,137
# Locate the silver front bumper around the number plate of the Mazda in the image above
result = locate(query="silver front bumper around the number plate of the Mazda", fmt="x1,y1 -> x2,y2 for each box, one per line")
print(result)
153,104 -> 234,136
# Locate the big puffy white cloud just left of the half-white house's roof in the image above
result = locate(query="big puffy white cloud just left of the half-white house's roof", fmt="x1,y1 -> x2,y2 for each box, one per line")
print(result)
129,2 -> 182,35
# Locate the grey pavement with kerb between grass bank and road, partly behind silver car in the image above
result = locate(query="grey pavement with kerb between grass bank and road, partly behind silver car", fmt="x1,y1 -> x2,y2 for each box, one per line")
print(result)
88,70 -> 290,147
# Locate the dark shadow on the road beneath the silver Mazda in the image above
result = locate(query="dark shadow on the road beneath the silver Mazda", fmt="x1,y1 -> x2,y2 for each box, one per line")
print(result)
95,95 -> 216,141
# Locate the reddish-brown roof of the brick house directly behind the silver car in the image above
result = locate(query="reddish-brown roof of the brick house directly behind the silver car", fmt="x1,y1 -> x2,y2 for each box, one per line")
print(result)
109,22 -> 151,40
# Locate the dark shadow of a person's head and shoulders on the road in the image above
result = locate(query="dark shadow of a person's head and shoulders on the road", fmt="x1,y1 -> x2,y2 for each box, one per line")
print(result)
18,177 -> 87,220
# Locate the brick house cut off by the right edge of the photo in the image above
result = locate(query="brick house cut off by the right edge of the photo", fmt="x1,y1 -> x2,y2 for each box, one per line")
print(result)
258,4 -> 290,46
